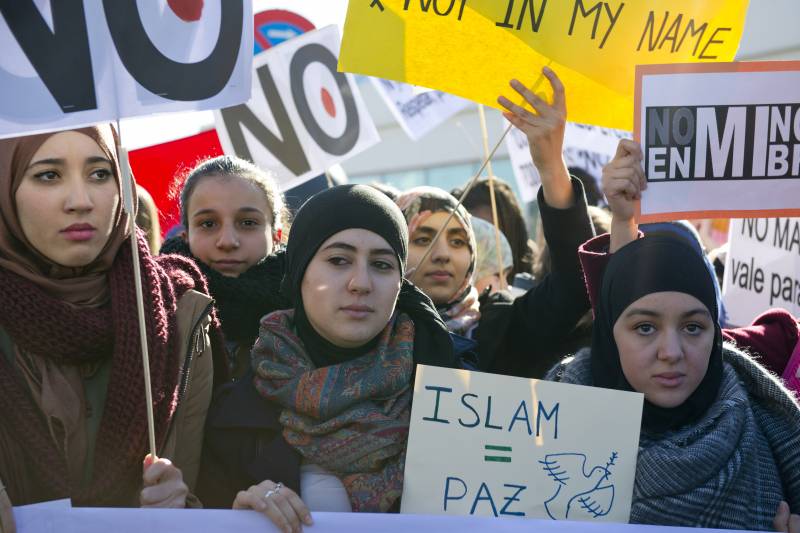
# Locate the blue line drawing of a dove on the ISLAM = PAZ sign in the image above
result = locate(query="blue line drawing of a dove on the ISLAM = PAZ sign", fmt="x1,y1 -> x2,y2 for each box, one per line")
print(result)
539,452 -> 619,520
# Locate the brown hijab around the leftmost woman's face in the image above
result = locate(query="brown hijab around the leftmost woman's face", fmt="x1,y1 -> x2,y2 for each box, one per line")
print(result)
0,124 -> 136,307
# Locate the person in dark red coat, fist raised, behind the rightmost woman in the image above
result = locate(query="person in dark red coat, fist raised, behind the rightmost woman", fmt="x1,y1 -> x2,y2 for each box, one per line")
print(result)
580,140 -> 800,392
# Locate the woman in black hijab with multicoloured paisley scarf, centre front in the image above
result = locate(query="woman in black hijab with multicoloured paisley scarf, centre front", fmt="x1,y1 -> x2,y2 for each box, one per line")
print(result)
198,185 -> 457,530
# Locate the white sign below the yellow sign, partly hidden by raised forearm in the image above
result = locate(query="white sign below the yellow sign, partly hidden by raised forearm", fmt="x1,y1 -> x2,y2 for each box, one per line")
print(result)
506,122 -> 631,202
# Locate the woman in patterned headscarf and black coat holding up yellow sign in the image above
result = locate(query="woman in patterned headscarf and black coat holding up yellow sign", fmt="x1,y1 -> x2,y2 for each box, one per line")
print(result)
397,69 -> 593,377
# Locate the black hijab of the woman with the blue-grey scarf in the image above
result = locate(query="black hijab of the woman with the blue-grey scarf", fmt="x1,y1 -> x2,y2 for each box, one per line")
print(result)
591,236 -> 722,433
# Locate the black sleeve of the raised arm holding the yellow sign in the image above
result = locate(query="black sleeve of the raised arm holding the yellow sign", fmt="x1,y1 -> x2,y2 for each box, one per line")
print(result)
489,178 -> 594,378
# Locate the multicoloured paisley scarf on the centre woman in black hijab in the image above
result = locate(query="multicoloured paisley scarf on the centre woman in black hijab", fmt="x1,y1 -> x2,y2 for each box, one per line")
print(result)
252,310 -> 414,512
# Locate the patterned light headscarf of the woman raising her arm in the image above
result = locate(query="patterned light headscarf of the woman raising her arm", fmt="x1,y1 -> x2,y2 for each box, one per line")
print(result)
396,187 -> 480,335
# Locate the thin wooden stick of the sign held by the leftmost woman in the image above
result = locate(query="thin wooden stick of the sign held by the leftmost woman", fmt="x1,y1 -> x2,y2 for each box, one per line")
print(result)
117,146 -> 157,460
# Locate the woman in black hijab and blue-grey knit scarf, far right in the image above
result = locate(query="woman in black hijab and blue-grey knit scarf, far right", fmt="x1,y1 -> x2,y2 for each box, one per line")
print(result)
548,236 -> 800,531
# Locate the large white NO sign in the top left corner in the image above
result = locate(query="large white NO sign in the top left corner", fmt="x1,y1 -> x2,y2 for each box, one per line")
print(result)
0,0 -> 253,138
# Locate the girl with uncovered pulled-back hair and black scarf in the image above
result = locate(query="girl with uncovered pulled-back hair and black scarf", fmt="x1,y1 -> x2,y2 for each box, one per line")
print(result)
161,156 -> 289,379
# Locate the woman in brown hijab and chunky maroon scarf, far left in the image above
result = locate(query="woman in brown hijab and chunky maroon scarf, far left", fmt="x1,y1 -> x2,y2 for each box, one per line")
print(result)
0,125 -> 215,530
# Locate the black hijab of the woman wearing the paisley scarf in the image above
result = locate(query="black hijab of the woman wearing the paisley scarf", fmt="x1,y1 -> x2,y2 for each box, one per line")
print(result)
283,185 -> 455,367
